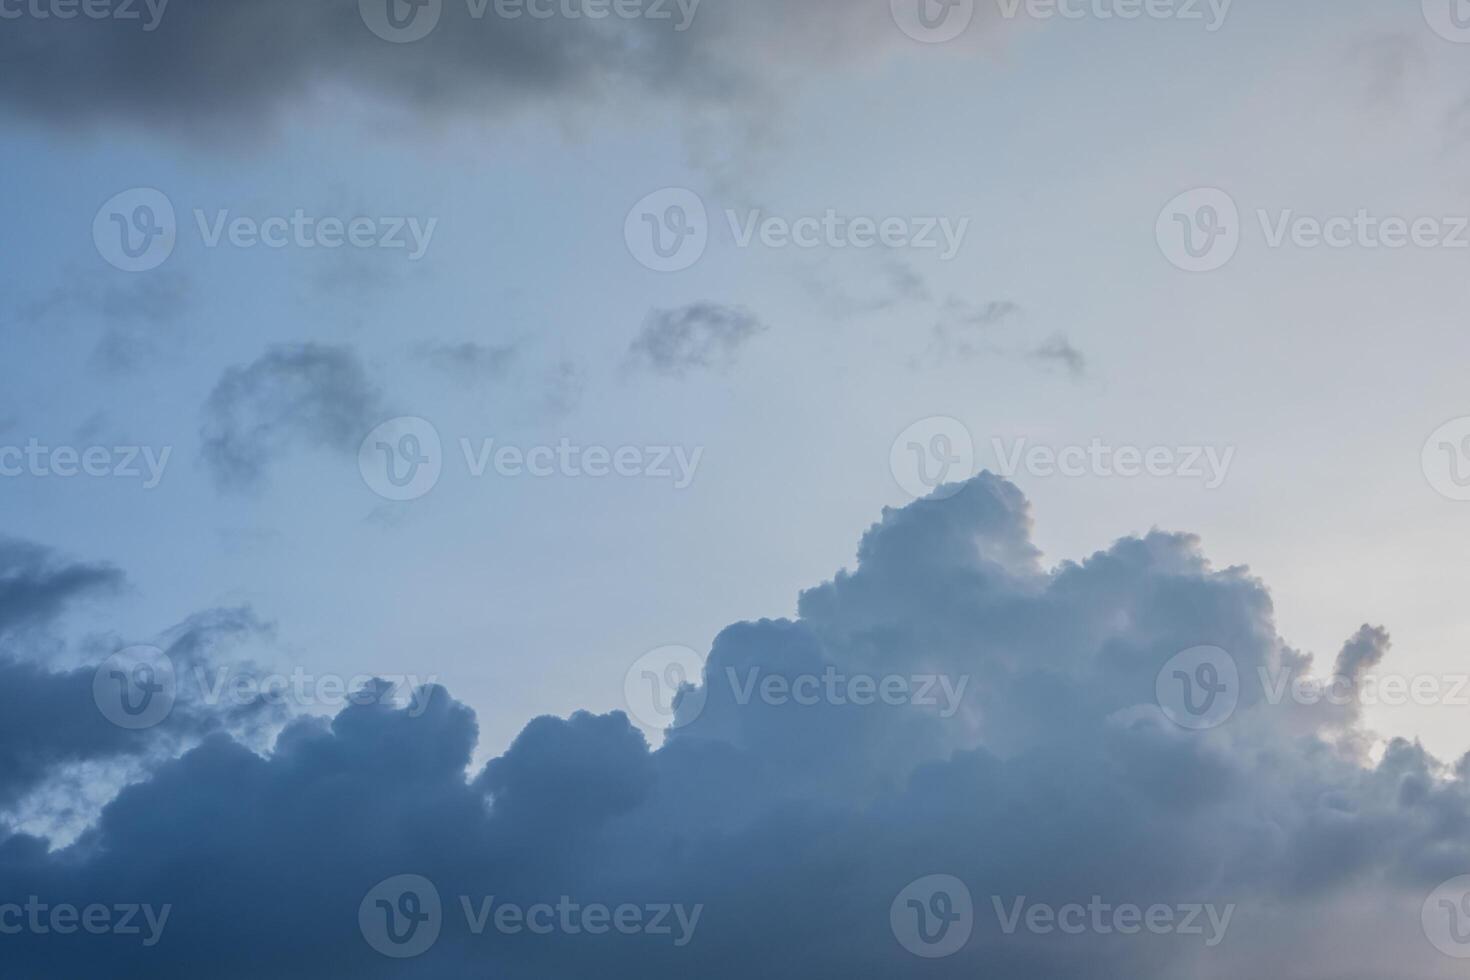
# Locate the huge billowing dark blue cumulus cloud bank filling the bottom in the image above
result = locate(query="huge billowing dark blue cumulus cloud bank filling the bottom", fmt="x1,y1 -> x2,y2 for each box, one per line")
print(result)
0,475 -> 1470,980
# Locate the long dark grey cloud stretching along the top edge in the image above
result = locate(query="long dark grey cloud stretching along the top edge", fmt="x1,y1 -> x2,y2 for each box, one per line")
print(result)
0,0 -> 1005,137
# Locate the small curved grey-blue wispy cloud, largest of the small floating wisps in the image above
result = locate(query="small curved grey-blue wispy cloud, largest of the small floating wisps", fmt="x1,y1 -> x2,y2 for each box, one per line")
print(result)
200,344 -> 381,489
